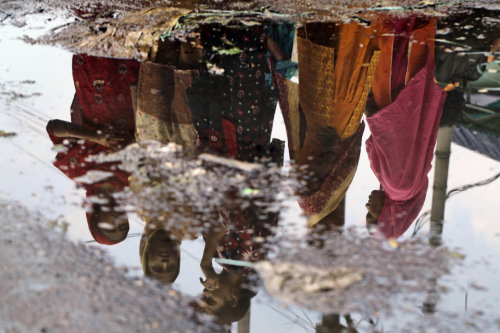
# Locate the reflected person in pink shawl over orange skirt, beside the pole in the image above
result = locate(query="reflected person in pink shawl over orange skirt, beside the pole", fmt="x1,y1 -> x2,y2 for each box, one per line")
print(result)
366,16 -> 446,237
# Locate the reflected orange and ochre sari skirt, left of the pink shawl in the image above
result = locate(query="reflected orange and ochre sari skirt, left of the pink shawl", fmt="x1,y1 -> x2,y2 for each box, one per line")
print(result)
297,23 -> 379,140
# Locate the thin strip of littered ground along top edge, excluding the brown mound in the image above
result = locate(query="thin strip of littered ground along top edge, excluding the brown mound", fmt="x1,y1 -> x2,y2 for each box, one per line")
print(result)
0,0 -> 498,22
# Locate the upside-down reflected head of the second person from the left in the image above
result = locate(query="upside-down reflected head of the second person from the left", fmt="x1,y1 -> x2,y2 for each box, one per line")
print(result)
147,232 -> 180,283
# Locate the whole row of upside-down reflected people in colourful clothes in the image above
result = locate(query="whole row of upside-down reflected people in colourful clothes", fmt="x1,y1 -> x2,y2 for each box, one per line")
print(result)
47,4 -> 500,326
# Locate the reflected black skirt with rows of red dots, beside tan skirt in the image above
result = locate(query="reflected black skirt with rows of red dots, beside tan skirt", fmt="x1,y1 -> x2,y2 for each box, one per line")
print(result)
188,22 -> 292,162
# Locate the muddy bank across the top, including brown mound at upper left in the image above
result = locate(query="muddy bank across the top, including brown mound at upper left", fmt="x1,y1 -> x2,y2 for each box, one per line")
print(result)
0,0 -> 498,61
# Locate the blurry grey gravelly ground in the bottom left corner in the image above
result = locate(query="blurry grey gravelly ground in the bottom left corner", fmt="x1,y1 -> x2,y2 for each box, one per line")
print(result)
0,201 -> 211,333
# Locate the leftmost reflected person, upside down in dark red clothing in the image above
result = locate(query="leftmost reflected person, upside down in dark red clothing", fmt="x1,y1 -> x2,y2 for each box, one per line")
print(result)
47,54 -> 139,245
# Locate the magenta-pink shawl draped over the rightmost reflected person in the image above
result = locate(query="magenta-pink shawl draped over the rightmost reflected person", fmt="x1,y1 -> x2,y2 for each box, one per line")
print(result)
366,56 -> 446,237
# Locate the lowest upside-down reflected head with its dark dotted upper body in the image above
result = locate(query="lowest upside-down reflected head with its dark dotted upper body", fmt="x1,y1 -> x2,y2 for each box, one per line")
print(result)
199,191 -> 278,324
